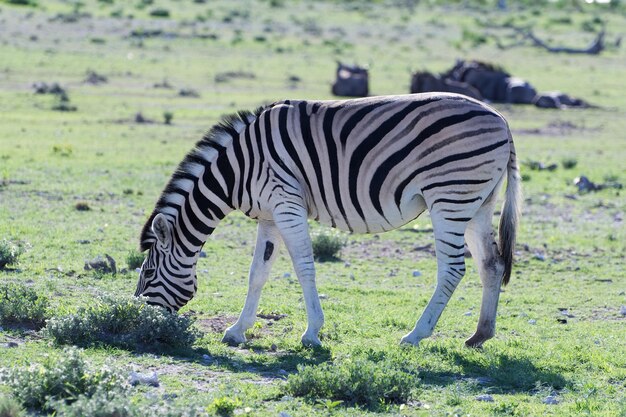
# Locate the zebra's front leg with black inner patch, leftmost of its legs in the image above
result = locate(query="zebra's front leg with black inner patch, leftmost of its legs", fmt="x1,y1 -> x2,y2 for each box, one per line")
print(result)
222,220 -> 280,346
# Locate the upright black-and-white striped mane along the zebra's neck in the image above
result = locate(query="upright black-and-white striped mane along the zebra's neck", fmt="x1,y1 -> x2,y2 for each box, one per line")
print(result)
139,105 -> 271,252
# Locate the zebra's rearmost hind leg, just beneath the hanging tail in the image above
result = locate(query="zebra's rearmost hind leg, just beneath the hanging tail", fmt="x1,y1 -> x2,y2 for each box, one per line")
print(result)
465,198 -> 504,347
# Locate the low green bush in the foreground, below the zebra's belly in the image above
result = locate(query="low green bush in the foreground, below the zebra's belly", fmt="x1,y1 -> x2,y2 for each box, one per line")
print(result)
287,358 -> 419,408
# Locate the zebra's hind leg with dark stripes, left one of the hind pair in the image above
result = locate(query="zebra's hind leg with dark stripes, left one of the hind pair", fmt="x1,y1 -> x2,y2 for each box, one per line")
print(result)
400,216 -> 466,346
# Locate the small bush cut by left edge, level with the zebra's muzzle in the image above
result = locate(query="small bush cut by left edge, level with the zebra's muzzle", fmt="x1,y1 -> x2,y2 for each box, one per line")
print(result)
0,283 -> 48,329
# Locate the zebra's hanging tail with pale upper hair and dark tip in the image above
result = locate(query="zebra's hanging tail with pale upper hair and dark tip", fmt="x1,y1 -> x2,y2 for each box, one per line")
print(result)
498,134 -> 522,285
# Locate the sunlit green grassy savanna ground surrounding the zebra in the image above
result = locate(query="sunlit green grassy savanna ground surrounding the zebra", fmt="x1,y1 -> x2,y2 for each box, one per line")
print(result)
0,0 -> 626,416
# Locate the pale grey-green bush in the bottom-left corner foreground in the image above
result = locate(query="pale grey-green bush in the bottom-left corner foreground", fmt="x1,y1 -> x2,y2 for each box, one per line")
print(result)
3,348 -> 127,411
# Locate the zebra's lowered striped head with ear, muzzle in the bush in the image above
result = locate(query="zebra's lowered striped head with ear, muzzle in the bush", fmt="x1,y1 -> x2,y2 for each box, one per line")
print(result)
135,213 -> 197,312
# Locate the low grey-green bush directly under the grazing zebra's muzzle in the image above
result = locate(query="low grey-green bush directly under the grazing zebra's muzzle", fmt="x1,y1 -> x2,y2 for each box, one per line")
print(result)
44,296 -> 198,351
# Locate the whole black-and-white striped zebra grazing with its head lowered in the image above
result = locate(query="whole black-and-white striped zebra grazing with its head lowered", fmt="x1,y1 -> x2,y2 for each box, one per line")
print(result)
136,93 -> 520,346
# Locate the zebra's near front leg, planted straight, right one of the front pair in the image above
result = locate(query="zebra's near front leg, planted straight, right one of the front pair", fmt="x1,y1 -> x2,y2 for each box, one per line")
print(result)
274,202 -> 324,346
